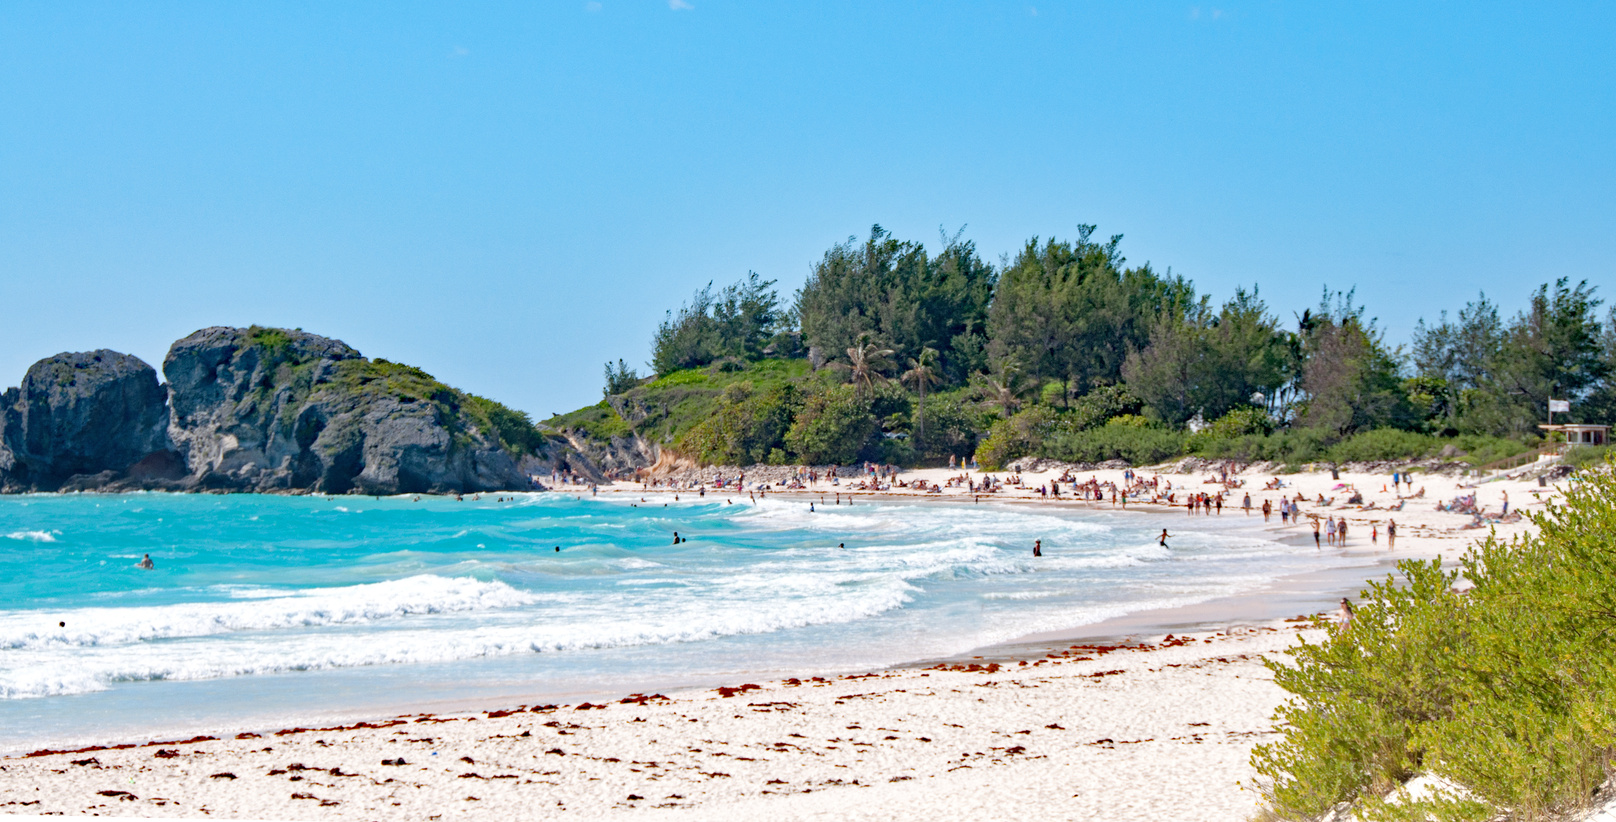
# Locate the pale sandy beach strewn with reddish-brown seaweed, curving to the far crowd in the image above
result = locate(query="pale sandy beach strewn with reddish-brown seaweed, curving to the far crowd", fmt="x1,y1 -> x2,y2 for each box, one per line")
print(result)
0,470 -> 1551,819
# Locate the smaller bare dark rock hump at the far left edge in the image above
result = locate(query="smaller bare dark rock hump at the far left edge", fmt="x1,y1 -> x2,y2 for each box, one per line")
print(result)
0,349 -> 168,491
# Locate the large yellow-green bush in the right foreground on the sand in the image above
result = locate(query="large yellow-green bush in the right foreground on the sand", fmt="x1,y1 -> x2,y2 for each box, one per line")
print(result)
1252,467 -> 1616,822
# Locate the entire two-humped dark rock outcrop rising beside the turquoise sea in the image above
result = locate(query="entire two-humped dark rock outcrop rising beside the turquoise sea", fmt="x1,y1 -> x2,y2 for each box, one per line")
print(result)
0,326 -> 549,494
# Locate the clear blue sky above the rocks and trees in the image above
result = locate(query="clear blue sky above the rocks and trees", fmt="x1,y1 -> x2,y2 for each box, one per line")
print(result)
0,0 -> 1616,418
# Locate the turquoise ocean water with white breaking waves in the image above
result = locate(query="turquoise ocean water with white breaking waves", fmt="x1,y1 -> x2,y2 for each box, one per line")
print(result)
0,494 -> 1335,751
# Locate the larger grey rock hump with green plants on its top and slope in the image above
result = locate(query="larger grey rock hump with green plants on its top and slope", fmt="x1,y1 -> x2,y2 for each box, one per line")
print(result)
163,328 -> 528,494
